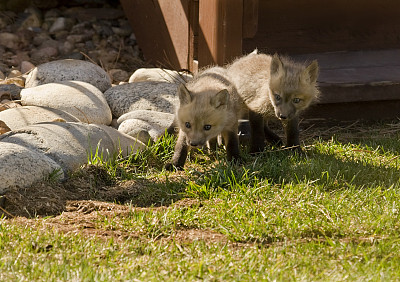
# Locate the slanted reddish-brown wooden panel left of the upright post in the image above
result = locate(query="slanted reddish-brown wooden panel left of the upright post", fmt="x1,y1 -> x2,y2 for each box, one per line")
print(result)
121,0 -> 194,69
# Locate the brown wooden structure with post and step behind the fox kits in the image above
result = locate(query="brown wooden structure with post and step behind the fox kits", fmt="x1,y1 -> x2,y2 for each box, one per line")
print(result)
121,0 -> 400,120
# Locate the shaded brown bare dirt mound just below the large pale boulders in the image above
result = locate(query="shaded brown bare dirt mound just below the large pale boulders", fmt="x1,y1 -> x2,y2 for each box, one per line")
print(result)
0,163 -> 168,218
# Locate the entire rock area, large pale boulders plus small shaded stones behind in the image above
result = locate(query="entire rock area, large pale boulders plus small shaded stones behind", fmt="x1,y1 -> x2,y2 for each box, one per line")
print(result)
0,1 -> 190,194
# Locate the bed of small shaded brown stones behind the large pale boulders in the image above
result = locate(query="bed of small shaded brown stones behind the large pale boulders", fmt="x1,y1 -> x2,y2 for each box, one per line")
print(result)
0,0 -> 149,83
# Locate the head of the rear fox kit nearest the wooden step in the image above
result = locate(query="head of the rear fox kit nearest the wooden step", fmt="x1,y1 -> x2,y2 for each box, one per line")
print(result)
270,54 -> 319,120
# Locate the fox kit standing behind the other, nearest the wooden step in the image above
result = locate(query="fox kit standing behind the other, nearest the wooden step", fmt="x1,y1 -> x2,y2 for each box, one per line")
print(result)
227,52 -> 319,152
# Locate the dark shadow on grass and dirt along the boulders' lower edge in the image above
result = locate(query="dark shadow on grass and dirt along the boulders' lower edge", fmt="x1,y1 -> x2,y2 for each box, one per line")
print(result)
0,166 -> 185,217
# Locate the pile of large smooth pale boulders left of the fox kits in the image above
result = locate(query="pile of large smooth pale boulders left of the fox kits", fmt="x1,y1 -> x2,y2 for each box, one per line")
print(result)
0,59 -> 191,193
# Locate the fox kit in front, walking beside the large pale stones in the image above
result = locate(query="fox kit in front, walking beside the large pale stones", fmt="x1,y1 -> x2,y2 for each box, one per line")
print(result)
166,67 -> 243,169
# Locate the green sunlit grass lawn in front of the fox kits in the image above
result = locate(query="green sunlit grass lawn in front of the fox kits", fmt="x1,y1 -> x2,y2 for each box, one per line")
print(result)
0,120 -> 400,281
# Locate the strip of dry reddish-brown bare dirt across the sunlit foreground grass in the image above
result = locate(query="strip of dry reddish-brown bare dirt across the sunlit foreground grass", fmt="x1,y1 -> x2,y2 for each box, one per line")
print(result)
8,199 -> 229,246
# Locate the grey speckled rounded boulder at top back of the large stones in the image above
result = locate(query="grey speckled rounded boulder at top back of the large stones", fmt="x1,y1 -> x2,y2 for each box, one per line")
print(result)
25,59 -> 111,92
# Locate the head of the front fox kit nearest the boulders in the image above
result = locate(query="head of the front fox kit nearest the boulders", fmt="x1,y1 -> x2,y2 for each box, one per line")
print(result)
177,84 -> 229,147
